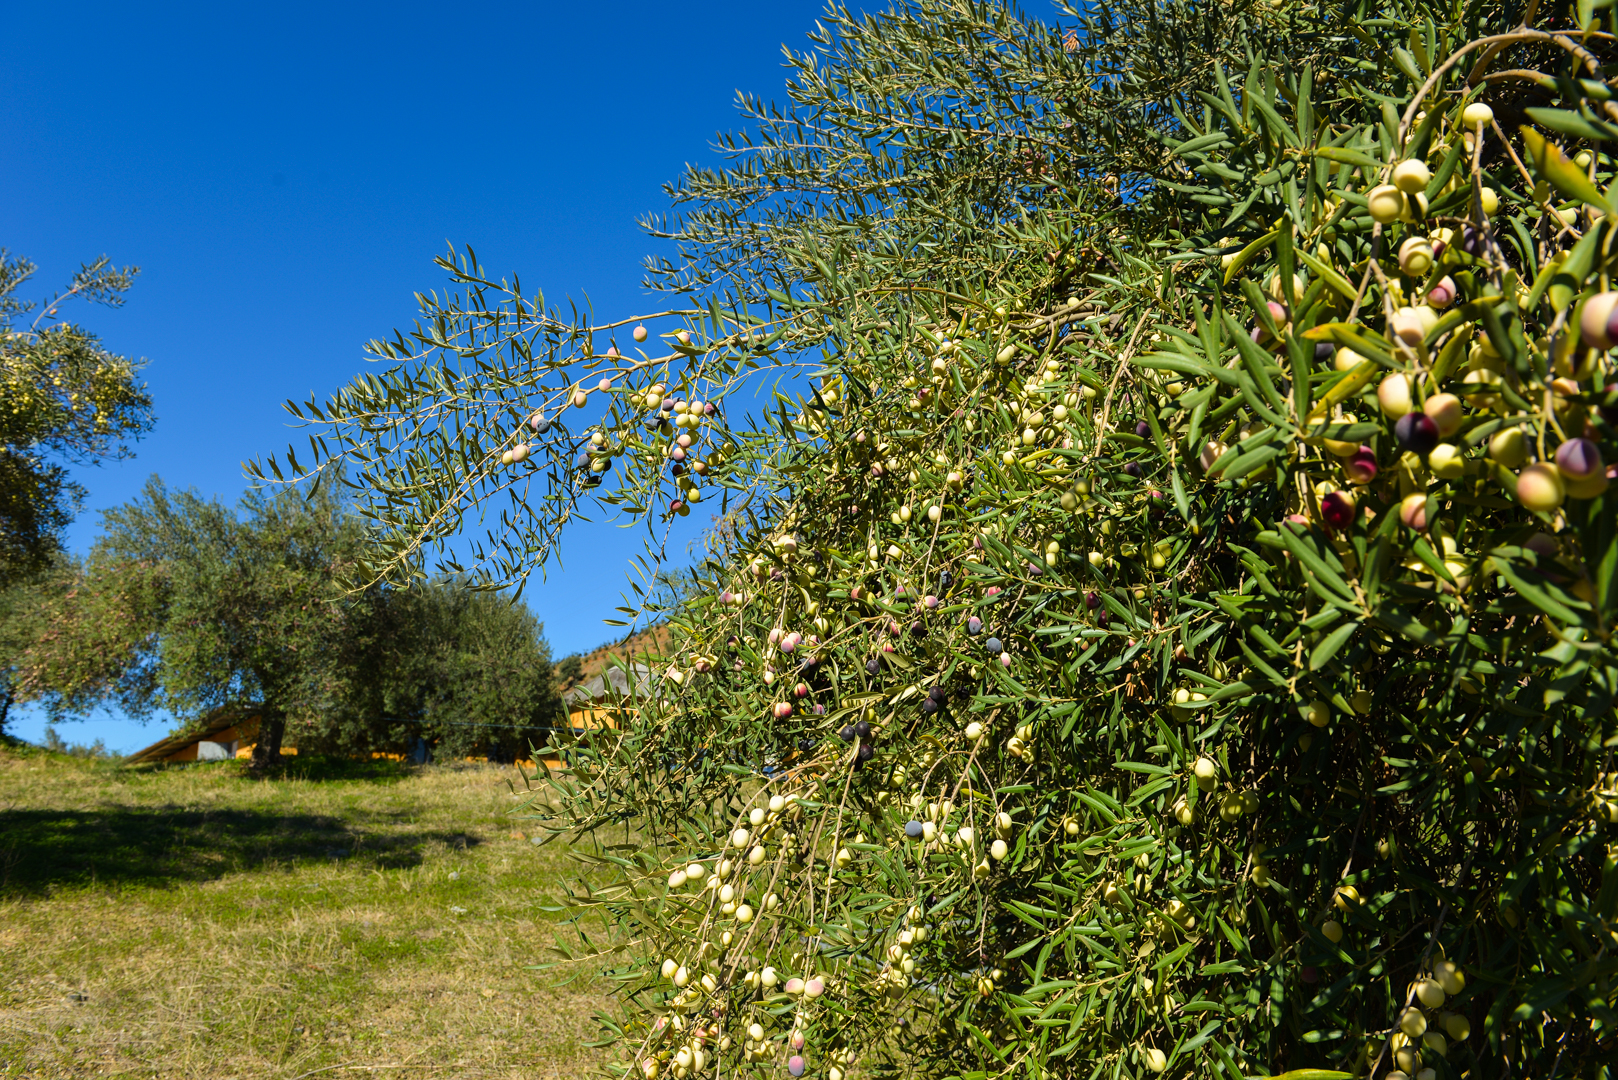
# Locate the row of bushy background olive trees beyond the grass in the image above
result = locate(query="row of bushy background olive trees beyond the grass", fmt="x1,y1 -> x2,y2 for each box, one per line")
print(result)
0,478 -> 565,766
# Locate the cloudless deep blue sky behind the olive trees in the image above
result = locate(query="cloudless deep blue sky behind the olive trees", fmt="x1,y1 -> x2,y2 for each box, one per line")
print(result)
0,0 -> 885,751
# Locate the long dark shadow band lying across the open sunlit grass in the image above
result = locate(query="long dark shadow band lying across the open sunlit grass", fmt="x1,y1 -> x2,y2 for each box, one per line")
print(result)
0,793 -> 479,899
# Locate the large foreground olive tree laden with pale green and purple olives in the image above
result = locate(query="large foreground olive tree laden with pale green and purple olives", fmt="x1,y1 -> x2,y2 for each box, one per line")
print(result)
249,2 -> 1618,1080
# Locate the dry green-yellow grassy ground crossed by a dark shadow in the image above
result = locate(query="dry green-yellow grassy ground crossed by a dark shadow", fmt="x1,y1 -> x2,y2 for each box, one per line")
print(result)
0,748 -> 604,1080
